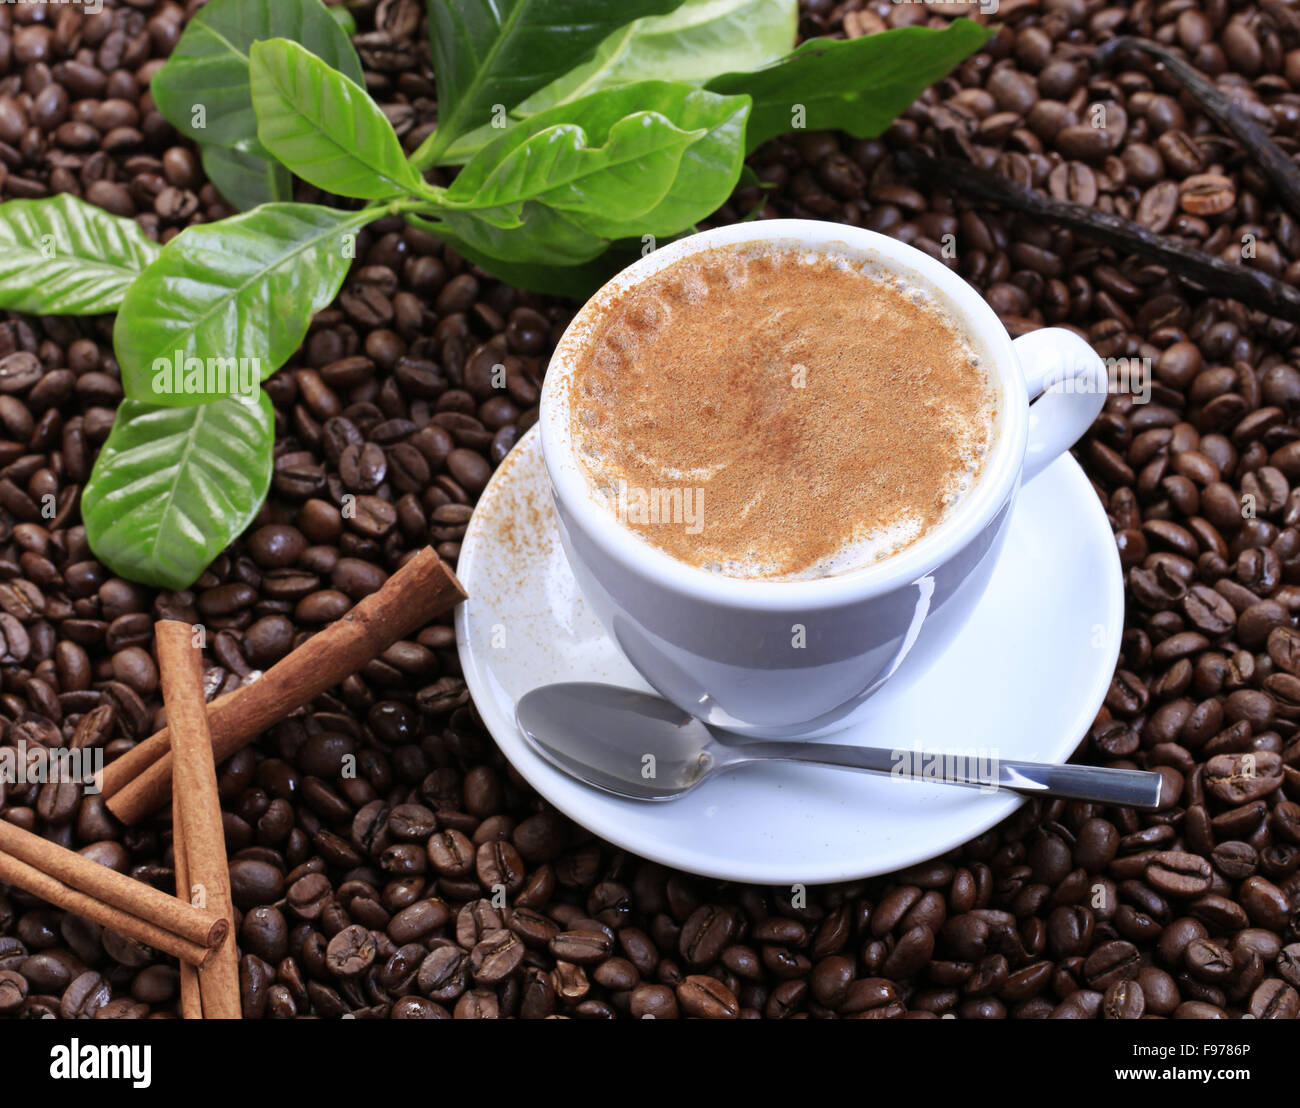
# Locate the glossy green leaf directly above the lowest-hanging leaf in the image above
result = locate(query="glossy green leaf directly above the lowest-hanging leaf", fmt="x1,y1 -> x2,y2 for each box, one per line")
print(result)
113,204 -> 376,406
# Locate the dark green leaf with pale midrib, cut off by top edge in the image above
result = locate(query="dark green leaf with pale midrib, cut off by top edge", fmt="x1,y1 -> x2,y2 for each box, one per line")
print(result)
412,0 -> 683,170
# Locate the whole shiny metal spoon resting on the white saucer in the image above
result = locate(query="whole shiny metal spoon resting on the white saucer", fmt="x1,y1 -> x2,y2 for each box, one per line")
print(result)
515,681 -> 1162,809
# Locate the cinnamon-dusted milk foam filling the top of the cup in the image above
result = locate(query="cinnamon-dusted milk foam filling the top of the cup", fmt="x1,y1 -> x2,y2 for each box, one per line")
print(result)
569,244 -> 996,579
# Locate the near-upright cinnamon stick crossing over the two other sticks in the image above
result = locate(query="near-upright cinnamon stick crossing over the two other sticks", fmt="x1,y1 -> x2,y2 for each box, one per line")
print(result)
153,619 -> 242,1020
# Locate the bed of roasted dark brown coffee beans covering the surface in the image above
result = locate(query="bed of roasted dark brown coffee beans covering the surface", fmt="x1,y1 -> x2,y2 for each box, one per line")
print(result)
0,0 -> 1300,1018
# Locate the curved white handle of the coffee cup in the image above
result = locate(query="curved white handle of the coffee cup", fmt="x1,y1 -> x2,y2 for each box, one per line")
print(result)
1011,326 -> 1108,482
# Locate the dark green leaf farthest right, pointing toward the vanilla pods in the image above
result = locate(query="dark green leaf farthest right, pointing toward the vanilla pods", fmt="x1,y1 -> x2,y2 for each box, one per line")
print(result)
705,20 -> 992,150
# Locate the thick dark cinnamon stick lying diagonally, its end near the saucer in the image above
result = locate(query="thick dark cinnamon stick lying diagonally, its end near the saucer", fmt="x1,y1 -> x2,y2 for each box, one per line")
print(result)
100,547 -> 465,824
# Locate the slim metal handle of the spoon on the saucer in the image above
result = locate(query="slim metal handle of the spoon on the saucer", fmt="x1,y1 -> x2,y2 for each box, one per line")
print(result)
731,743 -> 1162,809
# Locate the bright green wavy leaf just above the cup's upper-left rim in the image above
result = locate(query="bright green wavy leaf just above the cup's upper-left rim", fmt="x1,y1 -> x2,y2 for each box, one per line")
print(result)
445,81 -> 749,240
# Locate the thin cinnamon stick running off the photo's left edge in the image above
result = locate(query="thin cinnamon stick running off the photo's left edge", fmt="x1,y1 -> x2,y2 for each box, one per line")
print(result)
0,819 -> 229,953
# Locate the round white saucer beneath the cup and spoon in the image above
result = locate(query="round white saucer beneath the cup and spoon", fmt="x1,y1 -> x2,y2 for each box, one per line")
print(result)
456,428 -> 1123,884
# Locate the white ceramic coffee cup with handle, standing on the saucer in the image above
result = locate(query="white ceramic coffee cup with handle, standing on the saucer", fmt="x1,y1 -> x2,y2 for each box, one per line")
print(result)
538,220 -> 1108,737
